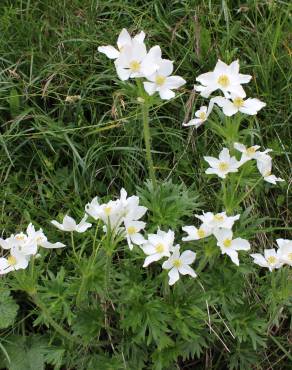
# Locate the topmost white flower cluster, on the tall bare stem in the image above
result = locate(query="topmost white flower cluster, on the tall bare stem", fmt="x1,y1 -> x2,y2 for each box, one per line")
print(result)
98,29 -> 186,100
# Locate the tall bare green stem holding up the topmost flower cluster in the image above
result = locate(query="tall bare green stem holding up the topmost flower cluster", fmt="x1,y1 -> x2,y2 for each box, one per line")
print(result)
136,79 -> 156,186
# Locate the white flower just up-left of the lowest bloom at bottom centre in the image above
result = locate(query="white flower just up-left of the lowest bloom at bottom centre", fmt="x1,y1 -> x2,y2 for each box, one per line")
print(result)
141,230 -> 174,267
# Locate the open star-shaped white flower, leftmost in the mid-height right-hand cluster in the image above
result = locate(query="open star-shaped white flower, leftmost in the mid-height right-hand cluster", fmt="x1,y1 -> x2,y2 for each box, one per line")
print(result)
204,148 -> 242,179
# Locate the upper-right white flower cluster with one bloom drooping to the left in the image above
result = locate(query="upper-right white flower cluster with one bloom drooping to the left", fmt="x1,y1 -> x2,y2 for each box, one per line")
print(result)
183,60 -> 266,128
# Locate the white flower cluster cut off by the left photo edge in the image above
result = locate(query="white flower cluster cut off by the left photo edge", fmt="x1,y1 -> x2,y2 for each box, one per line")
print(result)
0,223 -> 65,275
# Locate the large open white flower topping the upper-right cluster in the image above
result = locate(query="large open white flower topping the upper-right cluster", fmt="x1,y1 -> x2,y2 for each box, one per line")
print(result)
194,60 -> 251,98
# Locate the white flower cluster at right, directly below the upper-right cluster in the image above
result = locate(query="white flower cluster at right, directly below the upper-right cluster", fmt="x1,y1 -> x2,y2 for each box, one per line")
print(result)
204,143 -> 284,184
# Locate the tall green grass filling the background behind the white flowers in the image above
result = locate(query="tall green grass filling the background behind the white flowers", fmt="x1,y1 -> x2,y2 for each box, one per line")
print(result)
0,0 -> 292,370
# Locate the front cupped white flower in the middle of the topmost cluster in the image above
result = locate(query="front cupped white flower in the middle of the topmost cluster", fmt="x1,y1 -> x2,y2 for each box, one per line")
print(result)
115,40 -> 161,81
